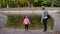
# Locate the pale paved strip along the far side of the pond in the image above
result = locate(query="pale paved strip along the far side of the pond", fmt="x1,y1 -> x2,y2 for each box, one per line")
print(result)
0,10 -> 58,15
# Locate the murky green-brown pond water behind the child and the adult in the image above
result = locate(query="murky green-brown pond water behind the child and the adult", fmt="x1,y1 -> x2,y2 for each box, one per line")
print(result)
6,15 -> 52,30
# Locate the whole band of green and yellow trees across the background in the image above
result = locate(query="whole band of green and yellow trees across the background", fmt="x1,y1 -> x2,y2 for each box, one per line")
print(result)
0,0 -> 60,8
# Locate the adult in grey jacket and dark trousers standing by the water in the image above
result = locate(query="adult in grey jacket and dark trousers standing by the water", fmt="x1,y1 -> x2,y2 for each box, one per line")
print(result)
41,6 -> 48,32
